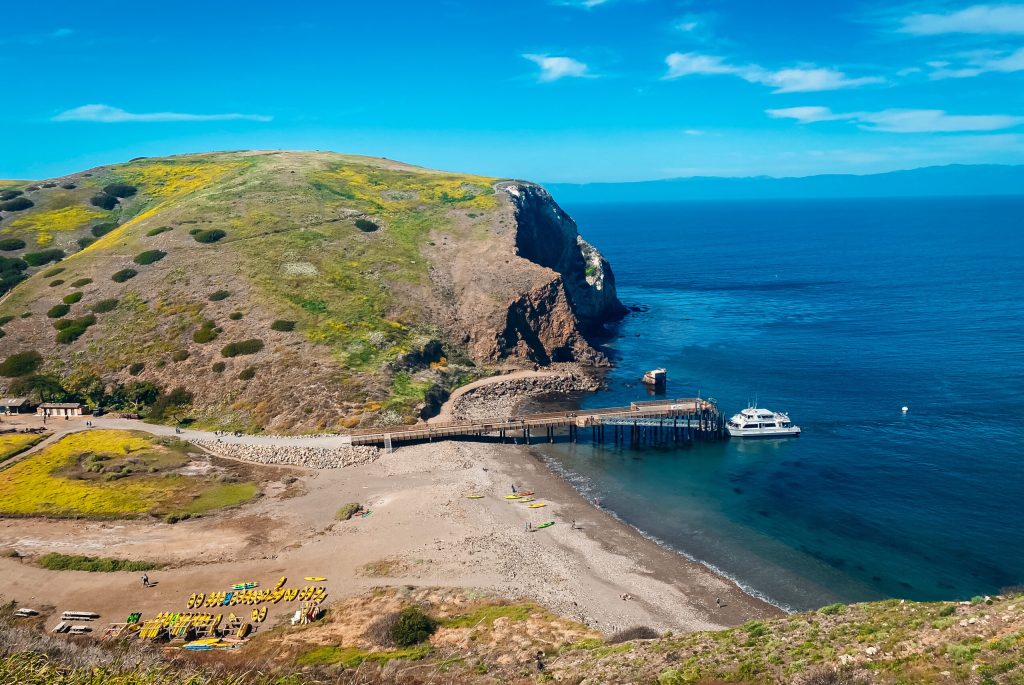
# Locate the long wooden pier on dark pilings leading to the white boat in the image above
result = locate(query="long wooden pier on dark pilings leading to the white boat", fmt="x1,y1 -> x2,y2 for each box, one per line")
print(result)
346,397 -> 727,449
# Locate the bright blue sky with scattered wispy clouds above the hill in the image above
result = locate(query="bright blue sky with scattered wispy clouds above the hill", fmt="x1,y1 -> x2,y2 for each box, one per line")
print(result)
0,0 -> 1024,181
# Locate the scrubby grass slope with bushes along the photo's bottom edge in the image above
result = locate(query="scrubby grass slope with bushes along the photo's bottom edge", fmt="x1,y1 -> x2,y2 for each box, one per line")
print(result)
0,587 -> 1024,685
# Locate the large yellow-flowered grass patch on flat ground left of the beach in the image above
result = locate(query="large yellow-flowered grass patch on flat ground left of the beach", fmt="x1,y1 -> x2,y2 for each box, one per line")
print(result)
0,430 -> 258,518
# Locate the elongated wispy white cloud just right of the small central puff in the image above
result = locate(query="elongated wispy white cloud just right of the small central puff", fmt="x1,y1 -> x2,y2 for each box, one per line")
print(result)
665,52 -> 883,93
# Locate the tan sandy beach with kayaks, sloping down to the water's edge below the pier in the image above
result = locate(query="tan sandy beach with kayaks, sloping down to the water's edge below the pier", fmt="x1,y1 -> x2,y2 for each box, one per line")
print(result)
0,411 -> 778,633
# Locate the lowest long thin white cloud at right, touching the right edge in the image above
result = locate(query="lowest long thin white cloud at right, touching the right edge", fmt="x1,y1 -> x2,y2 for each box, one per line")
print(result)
765,106 -> 1024,133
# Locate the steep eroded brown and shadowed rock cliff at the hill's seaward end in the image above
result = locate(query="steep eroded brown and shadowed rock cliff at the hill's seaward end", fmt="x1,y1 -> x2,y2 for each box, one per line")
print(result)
438,181 -> 627,365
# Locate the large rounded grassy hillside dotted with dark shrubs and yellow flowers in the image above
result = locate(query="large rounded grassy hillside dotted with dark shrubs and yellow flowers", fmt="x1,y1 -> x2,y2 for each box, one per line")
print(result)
0,152 -> 606,431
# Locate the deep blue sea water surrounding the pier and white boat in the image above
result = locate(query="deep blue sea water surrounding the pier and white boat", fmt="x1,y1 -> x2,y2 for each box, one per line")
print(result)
536,198 -> 1024,608
